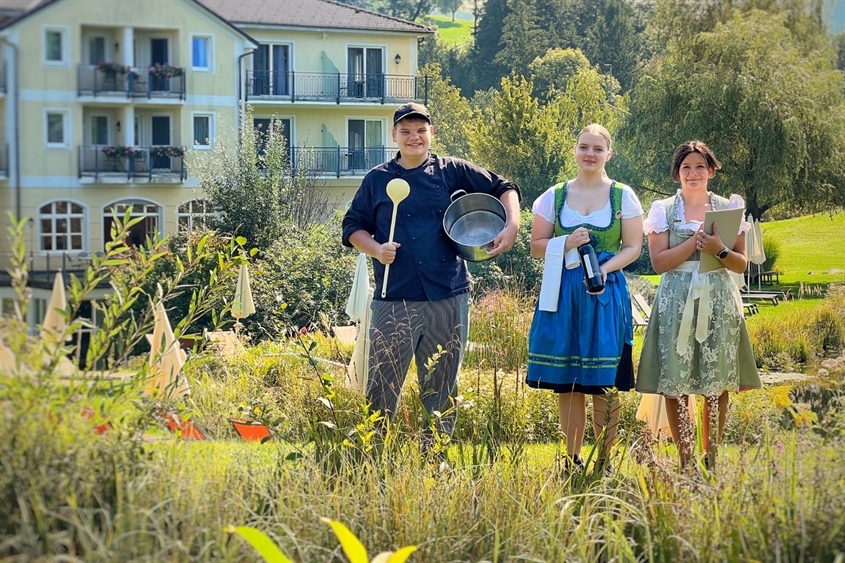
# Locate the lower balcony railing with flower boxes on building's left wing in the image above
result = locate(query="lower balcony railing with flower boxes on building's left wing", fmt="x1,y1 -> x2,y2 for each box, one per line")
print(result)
79,145 -> 188,182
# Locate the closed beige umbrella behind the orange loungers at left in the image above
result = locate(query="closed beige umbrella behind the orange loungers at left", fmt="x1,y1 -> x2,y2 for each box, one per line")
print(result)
147,301 -> 191,397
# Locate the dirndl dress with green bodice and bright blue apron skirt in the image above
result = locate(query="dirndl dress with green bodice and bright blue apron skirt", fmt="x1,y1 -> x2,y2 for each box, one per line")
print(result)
526,183 -> 634,395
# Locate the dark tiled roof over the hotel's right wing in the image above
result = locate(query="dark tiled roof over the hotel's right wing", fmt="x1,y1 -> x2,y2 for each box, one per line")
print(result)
199,0 -> 434,34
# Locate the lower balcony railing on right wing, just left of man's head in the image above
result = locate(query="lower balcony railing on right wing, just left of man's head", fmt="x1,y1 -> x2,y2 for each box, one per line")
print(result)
290,147 -> 389,178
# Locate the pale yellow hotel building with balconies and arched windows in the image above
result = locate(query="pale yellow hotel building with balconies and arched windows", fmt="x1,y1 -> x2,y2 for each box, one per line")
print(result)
0,0 -> 433,324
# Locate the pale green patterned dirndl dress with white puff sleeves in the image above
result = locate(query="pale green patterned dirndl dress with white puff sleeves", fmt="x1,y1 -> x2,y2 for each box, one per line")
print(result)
636,195 -> 761,397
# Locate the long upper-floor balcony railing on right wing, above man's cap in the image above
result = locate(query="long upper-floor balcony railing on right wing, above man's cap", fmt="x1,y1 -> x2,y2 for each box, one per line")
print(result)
246,70 -> 428,104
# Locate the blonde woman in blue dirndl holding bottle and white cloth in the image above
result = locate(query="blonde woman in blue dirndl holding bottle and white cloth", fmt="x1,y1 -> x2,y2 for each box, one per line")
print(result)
526,124 -> 643,470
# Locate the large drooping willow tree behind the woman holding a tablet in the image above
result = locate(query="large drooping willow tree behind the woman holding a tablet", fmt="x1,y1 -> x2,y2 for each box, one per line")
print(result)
624,10 -> 845,217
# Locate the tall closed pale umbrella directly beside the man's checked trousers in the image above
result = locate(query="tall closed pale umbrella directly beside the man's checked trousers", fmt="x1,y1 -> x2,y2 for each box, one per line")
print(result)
346,252 -> 373,395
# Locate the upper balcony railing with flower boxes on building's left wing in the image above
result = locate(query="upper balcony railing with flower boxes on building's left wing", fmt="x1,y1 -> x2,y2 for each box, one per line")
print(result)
79,65 -> 185,100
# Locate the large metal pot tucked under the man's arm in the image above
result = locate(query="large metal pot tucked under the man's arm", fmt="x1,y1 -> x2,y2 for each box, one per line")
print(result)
443,190 -> 508,262
